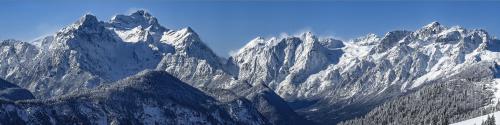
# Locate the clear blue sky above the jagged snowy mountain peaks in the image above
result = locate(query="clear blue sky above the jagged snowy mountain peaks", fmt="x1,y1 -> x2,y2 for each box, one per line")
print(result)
0,0 -> 500,56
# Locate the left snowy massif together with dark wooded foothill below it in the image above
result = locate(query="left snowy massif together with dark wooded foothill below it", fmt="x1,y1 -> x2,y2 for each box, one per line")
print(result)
0,10 -> 309,124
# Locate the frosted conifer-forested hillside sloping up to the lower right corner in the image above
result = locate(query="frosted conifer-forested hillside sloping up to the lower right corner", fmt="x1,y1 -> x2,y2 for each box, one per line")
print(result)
340,64 -> 498,125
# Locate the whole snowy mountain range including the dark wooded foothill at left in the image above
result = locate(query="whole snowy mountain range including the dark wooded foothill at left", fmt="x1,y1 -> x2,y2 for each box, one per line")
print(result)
0,10 -> 500,124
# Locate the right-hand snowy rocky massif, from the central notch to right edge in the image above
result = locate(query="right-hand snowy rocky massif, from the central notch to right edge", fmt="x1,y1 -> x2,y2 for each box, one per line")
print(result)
233,22 -> 500,124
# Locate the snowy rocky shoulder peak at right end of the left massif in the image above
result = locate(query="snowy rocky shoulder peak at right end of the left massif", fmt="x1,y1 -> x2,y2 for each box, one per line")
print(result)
156,27 -> 243,88
